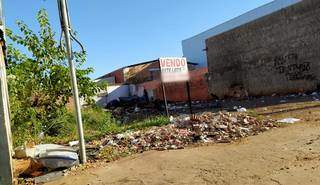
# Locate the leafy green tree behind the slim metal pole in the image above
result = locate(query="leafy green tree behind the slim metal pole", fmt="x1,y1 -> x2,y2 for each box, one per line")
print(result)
7,9 -> 104,142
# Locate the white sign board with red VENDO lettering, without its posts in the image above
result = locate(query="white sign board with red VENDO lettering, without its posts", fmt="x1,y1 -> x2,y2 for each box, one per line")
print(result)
159,57 -> 190,83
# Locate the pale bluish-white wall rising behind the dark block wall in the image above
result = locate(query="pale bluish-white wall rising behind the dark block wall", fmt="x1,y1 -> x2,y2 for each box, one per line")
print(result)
182,0 -> 302,67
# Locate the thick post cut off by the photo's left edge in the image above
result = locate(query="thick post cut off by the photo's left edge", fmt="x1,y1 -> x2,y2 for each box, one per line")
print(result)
0,0 -> 13,185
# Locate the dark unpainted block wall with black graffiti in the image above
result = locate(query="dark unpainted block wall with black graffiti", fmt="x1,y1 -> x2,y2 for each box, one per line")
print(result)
206,0 -> 320,98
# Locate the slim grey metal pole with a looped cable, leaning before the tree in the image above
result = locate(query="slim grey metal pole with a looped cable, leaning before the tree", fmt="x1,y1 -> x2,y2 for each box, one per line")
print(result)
58,0 -> 87,163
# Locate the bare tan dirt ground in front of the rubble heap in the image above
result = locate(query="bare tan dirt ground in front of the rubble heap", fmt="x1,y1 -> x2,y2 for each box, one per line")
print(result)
47,102 -> 320,185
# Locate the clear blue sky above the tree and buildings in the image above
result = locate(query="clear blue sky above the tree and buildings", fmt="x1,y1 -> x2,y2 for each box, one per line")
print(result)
3,0 -> 272,78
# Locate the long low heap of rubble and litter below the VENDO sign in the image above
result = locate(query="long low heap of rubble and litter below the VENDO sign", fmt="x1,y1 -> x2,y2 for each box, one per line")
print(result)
95,112 -> 275,158
